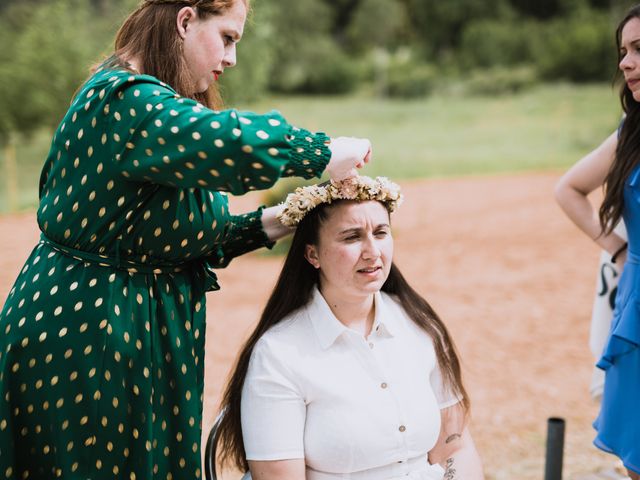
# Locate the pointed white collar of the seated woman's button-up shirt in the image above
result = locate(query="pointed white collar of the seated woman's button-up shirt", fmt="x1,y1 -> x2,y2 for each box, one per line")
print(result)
307,287 -> 395,350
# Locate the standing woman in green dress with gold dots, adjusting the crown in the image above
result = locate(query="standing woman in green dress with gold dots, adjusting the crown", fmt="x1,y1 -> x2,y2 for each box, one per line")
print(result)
0,0 -> 370,479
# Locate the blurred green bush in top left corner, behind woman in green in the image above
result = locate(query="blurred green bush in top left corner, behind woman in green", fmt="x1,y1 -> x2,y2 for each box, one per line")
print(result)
0,0 -> 127,139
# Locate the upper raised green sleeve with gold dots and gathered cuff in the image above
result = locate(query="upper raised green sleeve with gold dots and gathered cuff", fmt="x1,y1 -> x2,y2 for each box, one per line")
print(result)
103,71 -> 329,191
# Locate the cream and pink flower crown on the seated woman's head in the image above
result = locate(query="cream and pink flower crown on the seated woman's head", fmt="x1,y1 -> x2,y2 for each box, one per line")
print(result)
278,176 -> 402,227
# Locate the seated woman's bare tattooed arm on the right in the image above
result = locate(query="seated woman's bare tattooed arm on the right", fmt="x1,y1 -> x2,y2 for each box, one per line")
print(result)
429,404 -> 484,480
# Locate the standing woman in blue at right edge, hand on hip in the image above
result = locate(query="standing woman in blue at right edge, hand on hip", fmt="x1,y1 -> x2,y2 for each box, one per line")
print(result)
556,5 -> 640,480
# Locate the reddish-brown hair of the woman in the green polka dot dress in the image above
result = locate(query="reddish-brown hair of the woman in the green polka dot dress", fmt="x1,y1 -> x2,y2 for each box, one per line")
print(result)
102,0 -> 249,108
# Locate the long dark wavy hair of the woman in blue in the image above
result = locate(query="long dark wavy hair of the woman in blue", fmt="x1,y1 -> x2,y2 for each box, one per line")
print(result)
598,5 -> 640,233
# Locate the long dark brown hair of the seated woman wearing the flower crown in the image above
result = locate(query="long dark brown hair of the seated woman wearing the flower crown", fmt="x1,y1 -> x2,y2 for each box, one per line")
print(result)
215,201 -> 469,471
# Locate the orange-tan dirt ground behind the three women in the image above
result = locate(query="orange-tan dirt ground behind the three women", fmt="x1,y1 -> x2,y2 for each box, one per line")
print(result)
0,173 -> 615,480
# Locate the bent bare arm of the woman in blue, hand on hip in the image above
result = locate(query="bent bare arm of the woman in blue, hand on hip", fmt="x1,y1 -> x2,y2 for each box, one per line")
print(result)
555,127 -> 624,253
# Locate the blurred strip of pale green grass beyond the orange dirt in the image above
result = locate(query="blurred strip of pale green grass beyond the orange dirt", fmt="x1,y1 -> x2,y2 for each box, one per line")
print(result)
0,84 -> 620,212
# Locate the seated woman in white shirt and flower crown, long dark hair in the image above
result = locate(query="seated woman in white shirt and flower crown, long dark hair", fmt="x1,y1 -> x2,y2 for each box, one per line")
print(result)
218,177 -> 483,480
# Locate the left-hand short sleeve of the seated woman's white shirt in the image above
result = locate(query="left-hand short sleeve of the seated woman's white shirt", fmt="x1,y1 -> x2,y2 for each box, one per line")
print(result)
241,340 -> 306,460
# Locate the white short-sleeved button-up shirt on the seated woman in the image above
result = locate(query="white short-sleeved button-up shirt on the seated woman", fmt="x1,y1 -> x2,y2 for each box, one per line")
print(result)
242,290 -> 459,480
